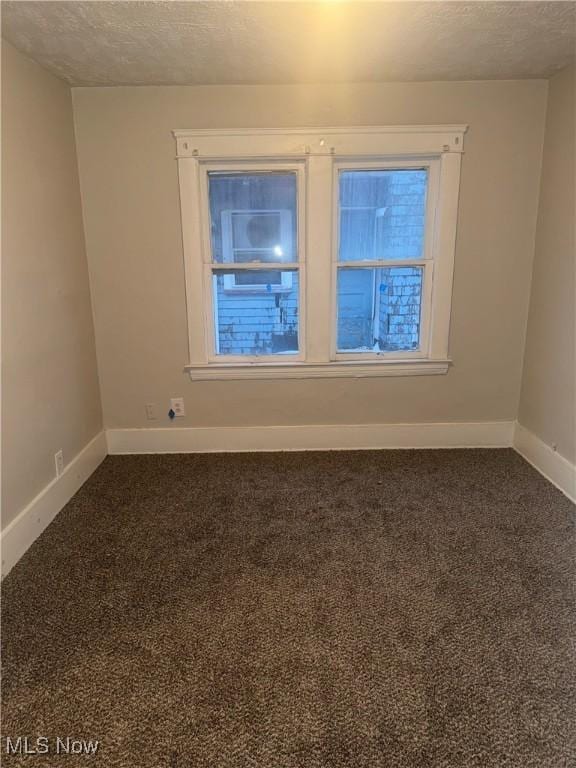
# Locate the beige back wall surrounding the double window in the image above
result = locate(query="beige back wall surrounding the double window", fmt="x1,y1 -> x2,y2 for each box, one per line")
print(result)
73,81 -> 547,427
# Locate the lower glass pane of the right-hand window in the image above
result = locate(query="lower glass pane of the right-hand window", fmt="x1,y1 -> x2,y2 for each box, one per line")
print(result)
338,267 -> 424,352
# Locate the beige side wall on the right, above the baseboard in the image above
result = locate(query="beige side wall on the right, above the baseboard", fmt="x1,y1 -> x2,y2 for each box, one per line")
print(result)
519,66 -> 576,462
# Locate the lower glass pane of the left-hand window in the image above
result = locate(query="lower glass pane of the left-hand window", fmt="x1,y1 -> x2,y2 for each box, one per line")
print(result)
212,269 -> 299,355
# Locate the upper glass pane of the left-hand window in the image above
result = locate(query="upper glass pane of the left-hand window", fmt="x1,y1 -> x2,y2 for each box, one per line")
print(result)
208,172 -> 298,264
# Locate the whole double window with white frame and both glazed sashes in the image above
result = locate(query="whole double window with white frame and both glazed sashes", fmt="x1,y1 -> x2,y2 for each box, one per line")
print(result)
175,126 -> 465,379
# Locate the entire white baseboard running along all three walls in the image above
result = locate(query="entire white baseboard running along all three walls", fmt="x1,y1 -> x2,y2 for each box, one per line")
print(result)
0,421 -> 576,576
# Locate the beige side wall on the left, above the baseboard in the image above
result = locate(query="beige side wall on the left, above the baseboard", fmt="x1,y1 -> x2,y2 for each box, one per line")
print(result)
2,42 -> 101,526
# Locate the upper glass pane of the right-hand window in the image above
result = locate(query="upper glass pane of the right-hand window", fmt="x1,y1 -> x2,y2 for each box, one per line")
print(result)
338,170 -> 428,261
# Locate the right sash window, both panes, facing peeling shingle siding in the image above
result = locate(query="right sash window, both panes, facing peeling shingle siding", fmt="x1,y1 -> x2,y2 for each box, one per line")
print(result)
336,163 -> 434,358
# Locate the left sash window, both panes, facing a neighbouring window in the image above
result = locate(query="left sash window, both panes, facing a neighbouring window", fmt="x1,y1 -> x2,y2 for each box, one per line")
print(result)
207,171 -> 300,360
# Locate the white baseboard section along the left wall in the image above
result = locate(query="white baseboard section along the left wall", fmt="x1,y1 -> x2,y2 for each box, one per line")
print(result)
0,432 -> 108,577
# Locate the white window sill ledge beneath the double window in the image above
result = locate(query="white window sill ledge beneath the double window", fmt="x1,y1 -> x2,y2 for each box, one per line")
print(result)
184,360 -> 450,381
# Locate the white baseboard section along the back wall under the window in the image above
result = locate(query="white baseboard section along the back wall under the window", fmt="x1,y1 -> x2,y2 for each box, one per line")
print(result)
106,421 -> 514,454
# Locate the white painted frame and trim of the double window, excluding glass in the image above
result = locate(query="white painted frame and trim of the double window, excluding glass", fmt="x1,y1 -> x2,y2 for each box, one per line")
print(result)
173,126 -> 467,380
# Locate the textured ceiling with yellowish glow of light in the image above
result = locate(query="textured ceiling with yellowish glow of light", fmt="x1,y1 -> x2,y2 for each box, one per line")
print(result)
2,0 -> 576,85
